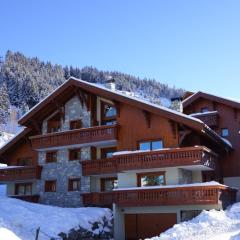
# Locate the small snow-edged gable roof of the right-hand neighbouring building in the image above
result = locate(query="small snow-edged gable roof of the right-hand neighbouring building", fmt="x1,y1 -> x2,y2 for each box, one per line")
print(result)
182,92 -> 240,109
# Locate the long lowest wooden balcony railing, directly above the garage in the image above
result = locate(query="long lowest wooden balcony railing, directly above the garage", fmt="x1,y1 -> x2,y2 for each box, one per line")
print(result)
83,185 -> 236,207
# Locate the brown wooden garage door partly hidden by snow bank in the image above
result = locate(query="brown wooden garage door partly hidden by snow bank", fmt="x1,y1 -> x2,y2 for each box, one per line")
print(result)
125,213 -> 177,240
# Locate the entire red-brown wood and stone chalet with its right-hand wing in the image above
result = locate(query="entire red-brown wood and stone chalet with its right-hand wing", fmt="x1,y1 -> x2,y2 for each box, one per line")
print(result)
0,78 -> 237,240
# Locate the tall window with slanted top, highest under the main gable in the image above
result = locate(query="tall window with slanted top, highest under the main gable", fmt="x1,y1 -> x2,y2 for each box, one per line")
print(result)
101,102 -> 117,125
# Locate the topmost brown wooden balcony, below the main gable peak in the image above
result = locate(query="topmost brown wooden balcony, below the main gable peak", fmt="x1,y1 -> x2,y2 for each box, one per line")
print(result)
30,125 -> 117,149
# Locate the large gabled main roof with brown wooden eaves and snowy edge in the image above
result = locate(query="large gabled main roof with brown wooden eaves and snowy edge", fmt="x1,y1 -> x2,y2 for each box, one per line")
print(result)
12,77 -> 230,148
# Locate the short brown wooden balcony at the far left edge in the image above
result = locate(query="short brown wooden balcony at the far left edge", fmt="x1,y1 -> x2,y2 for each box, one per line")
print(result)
0,166 -> 42,182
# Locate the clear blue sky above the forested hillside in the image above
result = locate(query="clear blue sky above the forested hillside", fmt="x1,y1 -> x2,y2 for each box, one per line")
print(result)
0,0 -> 240,99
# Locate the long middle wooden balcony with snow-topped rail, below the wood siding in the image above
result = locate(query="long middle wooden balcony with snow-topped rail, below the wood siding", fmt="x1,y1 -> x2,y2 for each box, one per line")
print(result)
82,146 -> 217,176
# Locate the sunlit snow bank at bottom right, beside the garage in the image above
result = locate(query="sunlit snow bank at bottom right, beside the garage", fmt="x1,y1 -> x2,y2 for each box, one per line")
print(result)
147,203 -> 240,240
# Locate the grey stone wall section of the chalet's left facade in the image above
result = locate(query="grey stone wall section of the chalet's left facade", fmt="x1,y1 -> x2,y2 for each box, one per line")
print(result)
37,97 -> 91,207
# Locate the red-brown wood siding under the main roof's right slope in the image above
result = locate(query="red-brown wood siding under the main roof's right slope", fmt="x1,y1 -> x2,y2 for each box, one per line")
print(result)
117,104 -> 178,151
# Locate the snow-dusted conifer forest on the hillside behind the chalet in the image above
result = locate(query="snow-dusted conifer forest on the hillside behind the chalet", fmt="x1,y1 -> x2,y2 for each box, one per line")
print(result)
0,51 -> 184,132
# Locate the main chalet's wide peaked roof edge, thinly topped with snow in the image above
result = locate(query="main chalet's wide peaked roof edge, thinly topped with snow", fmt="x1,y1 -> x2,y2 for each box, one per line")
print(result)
16,77 -> 229,150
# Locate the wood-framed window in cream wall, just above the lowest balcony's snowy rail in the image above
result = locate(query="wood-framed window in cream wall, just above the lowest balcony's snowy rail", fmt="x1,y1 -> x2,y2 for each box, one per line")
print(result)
137,172 -> 165,187
